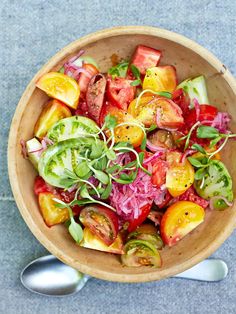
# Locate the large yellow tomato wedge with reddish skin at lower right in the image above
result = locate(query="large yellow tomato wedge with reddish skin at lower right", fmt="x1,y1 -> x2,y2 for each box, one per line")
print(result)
161,201 -> 205,246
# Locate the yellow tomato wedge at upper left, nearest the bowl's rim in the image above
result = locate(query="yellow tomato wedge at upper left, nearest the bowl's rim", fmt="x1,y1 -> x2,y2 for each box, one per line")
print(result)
36,72 -> 80,109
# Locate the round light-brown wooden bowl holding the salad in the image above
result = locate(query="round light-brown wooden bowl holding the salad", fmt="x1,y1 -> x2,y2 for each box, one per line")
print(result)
8,26 -> 236,282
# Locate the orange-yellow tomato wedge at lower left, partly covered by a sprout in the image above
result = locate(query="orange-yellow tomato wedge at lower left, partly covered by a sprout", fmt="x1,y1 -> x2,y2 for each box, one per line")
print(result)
38,192 -> 69,227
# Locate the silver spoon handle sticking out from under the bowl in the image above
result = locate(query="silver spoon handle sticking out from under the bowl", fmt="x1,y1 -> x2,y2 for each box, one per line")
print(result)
174,259 -> 228,281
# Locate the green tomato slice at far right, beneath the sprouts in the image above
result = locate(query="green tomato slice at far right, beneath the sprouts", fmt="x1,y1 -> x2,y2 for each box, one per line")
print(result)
194,160 -> 233,209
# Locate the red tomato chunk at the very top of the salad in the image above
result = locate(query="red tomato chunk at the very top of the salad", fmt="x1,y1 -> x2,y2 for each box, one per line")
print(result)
130,45 -> 161,75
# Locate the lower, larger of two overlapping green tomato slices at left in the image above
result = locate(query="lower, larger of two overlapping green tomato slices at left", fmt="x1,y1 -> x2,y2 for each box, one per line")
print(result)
38,137 -> 104,188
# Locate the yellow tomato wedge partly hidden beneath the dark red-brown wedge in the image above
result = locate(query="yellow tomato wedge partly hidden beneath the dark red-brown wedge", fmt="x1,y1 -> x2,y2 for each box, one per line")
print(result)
80,228 -> 124,254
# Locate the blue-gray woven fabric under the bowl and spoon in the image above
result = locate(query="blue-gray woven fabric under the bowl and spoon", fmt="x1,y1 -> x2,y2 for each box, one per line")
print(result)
0,0 -> 236,314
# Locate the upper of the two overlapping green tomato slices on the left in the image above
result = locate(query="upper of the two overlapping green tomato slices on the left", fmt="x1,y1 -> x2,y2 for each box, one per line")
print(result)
47,116 -> 99,143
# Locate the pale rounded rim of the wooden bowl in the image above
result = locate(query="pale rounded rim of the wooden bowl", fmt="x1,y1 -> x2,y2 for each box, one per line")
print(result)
8,26 -> 236,282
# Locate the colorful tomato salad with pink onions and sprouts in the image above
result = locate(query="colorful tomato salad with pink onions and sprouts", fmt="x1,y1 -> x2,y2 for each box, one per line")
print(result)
21,45 -> 236,267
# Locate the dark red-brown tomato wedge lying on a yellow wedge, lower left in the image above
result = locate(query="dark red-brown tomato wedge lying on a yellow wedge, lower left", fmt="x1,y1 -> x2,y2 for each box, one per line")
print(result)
79,205 -> 118,245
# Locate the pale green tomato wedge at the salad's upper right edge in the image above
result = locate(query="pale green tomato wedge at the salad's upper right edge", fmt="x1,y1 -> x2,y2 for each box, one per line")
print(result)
177,75 -> 209,107
